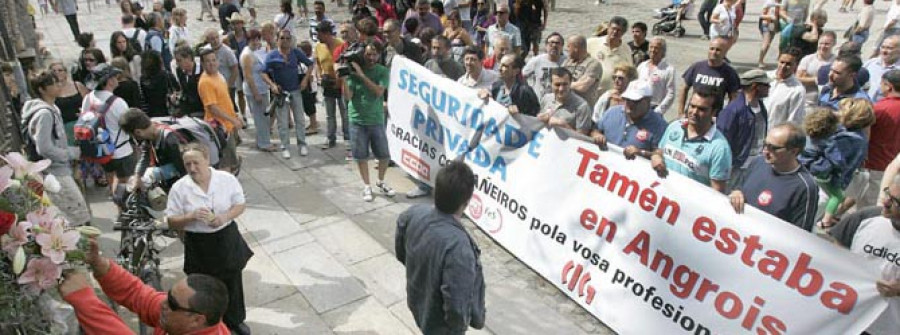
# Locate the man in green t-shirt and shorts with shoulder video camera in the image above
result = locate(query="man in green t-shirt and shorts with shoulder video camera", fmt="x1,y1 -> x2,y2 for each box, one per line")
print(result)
343,42 -> 395,201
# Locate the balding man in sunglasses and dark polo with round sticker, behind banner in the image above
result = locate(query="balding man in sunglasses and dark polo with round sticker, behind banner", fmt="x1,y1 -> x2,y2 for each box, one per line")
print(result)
729,123 -> 819,231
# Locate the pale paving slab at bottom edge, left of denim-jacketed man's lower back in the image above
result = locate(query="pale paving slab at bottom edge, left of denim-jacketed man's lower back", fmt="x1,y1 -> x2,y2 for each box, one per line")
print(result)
322,297 -> 412,335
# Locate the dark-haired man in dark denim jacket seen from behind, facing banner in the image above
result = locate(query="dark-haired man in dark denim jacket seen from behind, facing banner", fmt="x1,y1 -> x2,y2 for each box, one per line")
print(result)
394,161 -> 485,335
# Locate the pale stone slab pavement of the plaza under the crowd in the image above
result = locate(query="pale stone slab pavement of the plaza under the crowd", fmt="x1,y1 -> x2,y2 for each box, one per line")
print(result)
37,0 -> 872,334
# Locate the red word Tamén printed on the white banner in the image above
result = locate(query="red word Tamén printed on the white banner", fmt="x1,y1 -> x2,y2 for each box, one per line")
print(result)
575,147 -> 681,226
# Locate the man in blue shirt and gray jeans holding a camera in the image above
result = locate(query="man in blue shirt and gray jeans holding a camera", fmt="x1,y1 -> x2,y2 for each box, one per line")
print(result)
262,29 -> 313,159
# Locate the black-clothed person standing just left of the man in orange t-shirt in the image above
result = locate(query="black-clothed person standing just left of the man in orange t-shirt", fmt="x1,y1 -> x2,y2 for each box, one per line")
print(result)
175,45 -> 203,119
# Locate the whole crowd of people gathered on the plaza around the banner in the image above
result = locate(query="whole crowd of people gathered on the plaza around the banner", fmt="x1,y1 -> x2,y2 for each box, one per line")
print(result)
5,0 -> 900,334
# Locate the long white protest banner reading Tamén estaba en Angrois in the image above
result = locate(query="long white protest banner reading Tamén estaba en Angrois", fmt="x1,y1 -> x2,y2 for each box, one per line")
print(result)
387,57 -> 886,334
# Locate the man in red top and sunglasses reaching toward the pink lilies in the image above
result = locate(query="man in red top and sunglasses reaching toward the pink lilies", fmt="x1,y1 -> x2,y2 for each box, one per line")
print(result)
59,241 -> 232,335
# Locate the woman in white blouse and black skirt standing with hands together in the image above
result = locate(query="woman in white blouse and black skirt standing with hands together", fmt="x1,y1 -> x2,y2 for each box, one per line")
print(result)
166,143 -> 253,333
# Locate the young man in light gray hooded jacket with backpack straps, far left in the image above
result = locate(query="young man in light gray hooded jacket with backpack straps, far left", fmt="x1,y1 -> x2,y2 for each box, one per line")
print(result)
22,71 -> 91,226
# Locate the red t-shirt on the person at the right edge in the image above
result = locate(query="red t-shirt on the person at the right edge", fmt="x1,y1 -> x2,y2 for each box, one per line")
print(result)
865,97 -> 900,171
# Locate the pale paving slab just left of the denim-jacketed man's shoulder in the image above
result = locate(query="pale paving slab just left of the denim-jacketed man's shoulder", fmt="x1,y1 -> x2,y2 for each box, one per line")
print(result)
309,220 -> 387,266
